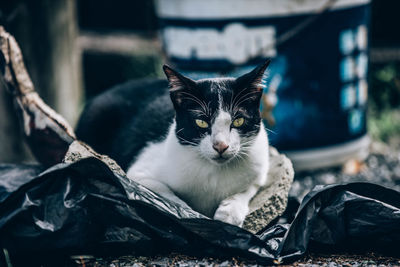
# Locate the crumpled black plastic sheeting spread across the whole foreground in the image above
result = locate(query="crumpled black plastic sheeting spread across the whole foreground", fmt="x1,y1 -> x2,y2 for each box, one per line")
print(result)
0,158 -> 400,264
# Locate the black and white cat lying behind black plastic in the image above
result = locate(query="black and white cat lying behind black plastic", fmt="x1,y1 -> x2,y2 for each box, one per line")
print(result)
77,61 -> 269,226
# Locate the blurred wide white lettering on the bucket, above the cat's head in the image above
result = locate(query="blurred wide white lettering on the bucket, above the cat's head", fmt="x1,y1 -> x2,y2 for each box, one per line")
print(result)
163,23 -> 276,64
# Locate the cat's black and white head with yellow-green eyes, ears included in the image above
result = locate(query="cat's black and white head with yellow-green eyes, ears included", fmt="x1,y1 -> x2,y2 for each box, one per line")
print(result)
164,61 -> 269,164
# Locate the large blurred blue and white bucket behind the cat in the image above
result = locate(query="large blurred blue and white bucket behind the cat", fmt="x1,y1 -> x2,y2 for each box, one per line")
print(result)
156,0 -> 370,170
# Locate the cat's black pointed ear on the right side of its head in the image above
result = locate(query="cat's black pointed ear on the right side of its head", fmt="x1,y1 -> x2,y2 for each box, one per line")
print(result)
236,59 -> 271,93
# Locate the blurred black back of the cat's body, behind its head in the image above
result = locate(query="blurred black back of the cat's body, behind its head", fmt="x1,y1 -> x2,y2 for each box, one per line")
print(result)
76,79 -> 175,171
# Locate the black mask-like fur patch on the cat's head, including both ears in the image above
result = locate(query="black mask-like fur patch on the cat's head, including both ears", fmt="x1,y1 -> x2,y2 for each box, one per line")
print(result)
164,60 -> 270,146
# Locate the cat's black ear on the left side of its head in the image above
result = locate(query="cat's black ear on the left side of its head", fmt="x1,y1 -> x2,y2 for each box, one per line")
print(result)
163,65 -> 196,105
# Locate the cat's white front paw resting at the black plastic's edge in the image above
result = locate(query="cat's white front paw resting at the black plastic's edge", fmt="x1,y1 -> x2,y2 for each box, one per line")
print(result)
214,199 -> 249,227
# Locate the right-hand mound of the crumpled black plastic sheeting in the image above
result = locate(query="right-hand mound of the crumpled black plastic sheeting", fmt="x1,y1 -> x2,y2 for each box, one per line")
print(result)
268,183 -> 400,262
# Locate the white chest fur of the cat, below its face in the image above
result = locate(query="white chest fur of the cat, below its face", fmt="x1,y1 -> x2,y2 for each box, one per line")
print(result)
127,123 -> 269,217
